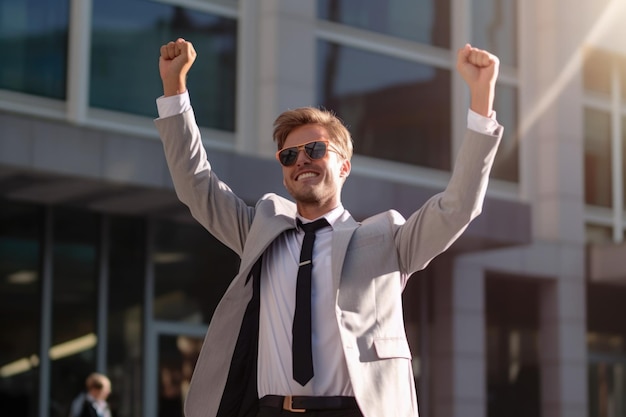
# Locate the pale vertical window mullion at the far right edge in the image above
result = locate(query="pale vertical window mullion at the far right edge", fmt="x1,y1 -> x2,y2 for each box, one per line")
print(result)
611,61 -> 624,243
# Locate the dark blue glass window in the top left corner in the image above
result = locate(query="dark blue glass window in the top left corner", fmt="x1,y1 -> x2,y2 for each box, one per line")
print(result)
0,0 -> 69,99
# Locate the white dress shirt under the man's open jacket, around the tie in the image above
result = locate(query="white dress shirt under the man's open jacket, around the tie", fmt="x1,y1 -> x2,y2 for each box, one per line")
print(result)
258,205 -> 354,397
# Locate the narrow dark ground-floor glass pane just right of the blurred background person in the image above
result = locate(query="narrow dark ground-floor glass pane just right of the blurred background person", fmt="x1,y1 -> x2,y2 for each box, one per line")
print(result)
107,216 -> 146,417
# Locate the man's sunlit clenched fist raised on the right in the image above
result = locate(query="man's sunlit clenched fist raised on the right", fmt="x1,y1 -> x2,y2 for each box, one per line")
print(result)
456,44 -> 500,117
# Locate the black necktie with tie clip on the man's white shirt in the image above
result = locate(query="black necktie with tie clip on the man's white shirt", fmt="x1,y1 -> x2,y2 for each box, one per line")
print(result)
291,218 -> 329,386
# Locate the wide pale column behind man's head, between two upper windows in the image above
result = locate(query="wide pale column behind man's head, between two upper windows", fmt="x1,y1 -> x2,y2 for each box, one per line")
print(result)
237,0 -> 316,156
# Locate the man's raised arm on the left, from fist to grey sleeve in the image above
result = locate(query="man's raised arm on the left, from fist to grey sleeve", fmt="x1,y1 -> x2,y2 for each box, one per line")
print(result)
155,39 -> 254,255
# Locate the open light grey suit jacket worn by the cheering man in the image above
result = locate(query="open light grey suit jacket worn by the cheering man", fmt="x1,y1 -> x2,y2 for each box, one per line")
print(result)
155,111 -> 503,417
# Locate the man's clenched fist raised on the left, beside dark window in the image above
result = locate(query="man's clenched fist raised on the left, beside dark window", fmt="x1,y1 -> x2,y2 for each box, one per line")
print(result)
159,38 -> 196,97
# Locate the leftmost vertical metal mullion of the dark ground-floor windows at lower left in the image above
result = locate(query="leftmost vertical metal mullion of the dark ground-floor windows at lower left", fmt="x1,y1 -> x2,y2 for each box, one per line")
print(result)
39,207 -> 54,417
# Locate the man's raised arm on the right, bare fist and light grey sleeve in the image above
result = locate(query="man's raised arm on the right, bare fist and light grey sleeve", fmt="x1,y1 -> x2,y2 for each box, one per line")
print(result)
395,44 -> 503,274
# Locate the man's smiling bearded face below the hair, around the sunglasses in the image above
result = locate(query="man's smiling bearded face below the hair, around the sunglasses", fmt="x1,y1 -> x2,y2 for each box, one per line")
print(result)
282,124 -> 350,219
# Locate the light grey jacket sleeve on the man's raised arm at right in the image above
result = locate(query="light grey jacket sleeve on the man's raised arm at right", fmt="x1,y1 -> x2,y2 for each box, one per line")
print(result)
394,126 -> 503,274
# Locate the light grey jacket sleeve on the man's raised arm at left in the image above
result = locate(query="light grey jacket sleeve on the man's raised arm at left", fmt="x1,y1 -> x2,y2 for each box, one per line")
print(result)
155,110 -> 254,256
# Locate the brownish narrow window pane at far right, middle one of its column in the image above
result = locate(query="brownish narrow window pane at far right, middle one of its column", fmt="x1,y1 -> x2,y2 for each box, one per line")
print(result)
585,109 -> 613,207
